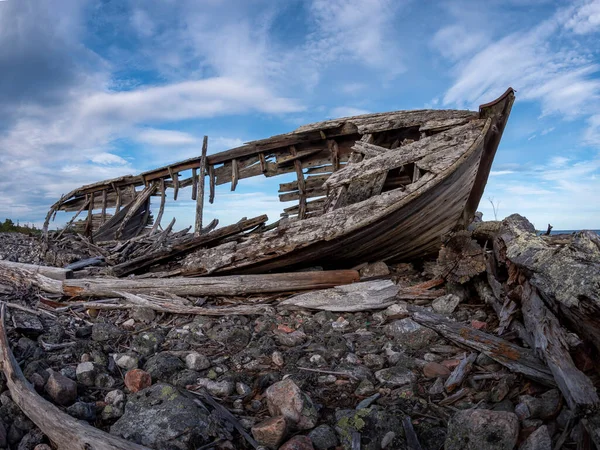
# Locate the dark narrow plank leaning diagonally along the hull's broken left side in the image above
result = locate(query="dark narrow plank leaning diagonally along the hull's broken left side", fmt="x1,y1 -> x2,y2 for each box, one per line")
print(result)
112,215 -> 268,277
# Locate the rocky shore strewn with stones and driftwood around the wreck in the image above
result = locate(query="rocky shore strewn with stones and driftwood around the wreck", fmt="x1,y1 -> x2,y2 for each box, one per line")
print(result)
0,216 -> 600,450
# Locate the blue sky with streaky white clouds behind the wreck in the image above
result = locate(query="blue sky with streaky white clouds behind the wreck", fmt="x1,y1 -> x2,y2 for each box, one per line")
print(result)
0,0 -> 600,229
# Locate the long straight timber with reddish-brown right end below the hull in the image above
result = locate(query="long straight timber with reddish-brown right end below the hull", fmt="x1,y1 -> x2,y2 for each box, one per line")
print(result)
62,270 -> 359,297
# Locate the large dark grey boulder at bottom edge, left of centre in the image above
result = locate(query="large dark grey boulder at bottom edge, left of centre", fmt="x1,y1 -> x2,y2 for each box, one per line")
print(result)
110,383 -> 215,450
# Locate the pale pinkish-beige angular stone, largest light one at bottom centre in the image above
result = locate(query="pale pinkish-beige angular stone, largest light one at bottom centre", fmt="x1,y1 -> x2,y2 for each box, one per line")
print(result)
266,378 -> 317,430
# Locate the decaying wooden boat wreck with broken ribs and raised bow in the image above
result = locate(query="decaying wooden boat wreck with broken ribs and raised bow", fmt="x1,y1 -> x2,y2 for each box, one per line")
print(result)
44,88 -> 514,276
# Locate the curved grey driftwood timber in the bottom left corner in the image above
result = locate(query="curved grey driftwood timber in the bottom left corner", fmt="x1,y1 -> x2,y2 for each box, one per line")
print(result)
0,305 -> 150,450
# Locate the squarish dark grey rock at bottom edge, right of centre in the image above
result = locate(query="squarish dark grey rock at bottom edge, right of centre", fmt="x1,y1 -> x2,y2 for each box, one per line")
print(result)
444,409 -> 519,450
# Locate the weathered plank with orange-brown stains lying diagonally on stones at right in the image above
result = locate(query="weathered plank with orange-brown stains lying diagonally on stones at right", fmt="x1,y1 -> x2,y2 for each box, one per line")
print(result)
408,306 -> 556,387
